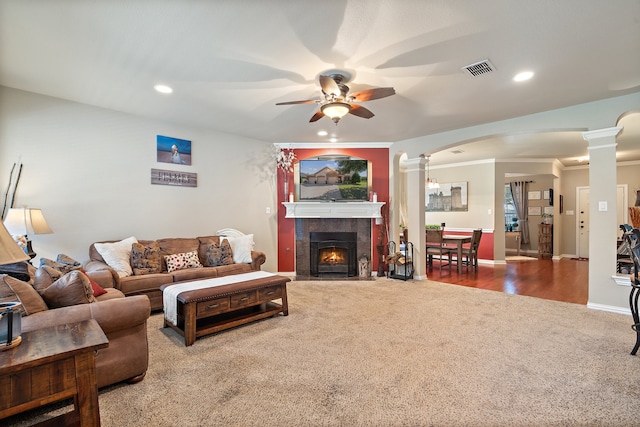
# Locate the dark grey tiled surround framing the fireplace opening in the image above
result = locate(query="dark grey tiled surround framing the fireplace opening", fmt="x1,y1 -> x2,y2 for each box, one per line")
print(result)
295,218 -> 372,280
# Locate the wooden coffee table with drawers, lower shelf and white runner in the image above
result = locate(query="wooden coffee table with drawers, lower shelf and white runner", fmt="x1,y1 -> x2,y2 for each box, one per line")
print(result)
160,274 -> 291,346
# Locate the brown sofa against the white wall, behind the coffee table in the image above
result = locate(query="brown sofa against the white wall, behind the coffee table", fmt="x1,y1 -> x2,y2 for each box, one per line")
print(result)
84,236 -> 266,310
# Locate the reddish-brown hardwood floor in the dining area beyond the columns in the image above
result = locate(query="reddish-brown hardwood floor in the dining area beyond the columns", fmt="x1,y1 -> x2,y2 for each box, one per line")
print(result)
427,258 -> 589,304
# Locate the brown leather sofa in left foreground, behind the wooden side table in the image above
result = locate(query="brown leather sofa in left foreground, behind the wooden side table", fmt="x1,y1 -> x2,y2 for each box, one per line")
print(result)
0,269 -> 151,387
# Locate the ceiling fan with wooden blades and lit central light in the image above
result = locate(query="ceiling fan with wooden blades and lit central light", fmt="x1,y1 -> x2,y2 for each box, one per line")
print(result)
276,73 -> 396,125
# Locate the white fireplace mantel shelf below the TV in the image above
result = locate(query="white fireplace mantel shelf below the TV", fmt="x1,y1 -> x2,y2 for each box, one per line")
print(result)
282,201 -> 385,218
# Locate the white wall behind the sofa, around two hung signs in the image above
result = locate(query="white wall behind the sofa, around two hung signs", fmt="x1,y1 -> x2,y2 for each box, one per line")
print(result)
0,87 -> 277,271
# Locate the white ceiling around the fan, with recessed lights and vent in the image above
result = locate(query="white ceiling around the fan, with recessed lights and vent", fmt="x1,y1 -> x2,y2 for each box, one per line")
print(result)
0,0 -> 640,165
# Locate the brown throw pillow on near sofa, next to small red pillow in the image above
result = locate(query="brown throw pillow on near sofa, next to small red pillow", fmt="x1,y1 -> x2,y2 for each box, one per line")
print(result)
41,270 -> 96,308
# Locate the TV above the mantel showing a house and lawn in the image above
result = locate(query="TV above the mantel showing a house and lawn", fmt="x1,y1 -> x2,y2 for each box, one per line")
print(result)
296,155 -> 371,202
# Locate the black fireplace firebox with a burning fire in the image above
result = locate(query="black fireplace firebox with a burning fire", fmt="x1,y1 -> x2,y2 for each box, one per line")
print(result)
309,232 -> 358,277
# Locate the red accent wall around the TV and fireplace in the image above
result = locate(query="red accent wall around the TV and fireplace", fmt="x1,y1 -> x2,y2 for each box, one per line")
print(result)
277,148 -> 389,272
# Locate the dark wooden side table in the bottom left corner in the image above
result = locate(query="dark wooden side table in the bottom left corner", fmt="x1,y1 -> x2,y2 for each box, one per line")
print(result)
0,319 -> 109,426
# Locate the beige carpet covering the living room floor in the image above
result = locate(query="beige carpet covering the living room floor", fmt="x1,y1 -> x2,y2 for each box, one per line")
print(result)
6,279 -> 640,427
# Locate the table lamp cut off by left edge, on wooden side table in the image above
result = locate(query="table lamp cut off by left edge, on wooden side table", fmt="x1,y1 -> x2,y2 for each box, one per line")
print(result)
0,221 -> 29,351
